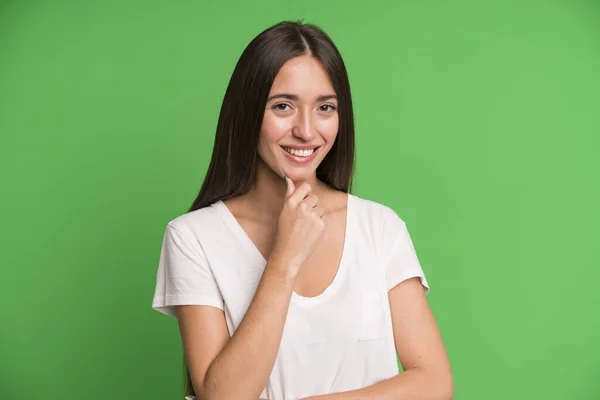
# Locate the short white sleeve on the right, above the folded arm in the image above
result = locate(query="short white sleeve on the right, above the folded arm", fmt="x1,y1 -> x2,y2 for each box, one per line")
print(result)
384,209 -> 429,293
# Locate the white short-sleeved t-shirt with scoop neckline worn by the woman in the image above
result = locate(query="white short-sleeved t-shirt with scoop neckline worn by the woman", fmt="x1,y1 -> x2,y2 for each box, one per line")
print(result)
152,194 -> 429,400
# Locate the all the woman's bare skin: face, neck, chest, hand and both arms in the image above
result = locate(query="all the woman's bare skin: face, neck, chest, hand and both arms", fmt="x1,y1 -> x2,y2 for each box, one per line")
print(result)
171,55 -> 453,400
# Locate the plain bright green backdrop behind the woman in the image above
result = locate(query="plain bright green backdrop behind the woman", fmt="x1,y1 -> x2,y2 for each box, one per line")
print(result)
0,0 -> 600,400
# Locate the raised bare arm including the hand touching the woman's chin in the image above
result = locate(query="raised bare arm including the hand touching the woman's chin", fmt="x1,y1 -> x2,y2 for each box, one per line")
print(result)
176,182 -> 325,400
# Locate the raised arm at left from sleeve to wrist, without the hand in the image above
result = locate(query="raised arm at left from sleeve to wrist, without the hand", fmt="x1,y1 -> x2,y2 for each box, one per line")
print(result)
176,253 -> 294,399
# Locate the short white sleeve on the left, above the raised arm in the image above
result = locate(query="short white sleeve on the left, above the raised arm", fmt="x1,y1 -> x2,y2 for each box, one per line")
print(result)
152,223 -> 224,316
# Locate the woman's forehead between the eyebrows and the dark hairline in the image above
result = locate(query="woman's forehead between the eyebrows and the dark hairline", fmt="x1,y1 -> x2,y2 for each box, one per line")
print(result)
271,56 -> 335,96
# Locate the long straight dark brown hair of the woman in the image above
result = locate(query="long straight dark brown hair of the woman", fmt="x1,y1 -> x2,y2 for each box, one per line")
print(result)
184,21 -> 354,395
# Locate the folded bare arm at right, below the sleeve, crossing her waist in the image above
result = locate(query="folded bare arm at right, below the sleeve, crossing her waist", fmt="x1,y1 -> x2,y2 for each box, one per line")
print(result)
306,278 -> 454,400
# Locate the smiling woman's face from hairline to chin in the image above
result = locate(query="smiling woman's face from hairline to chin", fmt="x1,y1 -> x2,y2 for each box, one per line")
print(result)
258,56 -> 339,182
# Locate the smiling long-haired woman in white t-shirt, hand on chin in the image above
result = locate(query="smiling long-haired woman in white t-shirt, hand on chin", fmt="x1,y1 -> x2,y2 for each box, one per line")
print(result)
153,22 -> 453,400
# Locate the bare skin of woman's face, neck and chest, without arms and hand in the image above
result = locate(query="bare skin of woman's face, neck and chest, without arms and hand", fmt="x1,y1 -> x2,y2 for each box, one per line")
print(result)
225,56 -> 347,297
